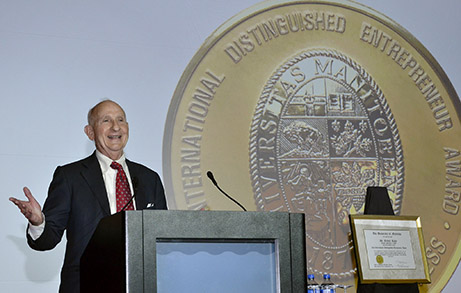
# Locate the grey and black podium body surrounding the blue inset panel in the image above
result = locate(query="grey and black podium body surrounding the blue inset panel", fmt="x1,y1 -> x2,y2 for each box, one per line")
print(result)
80,210 -> 306,292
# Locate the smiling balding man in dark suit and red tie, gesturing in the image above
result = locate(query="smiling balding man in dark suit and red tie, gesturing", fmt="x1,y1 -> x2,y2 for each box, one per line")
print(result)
10,100 -> 167,292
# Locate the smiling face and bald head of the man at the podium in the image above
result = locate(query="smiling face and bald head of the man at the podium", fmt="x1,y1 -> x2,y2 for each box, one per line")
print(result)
85,101 -> 128,160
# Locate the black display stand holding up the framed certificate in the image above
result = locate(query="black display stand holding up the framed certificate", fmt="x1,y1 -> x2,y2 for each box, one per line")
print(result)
357,187 -> 419,293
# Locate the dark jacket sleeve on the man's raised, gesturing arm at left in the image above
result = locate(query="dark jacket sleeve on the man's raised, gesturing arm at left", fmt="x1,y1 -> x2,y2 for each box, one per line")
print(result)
27,167 -> 72,250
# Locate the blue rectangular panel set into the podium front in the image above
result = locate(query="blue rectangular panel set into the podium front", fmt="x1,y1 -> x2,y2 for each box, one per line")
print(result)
156,239 -> 279,293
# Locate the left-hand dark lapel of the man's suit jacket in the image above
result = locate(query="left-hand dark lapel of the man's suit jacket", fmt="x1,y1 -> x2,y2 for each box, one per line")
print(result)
81,153 -> 111,215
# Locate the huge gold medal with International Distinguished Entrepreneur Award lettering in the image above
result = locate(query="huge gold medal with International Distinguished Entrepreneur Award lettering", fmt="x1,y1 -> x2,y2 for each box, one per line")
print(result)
163,0 -> 461,292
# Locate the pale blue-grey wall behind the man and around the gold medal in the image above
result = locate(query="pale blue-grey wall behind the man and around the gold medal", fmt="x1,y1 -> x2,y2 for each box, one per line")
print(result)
0,0 -> 461,292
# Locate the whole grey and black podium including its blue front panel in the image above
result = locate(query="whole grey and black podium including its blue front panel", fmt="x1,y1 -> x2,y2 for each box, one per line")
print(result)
80,210 -> 306,292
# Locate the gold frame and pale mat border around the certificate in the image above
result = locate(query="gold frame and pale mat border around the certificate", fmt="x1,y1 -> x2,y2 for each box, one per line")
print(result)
350,215 -> 431,284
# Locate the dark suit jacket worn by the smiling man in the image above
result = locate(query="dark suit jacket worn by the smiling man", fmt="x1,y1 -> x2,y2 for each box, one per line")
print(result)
27,153 -> 167,292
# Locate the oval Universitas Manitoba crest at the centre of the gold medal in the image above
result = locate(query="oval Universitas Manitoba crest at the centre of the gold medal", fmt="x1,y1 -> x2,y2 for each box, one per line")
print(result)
249,49 -> 404,277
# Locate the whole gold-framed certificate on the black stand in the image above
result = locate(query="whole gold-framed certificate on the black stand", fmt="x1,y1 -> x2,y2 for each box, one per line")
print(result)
350,215 -> 430,284
